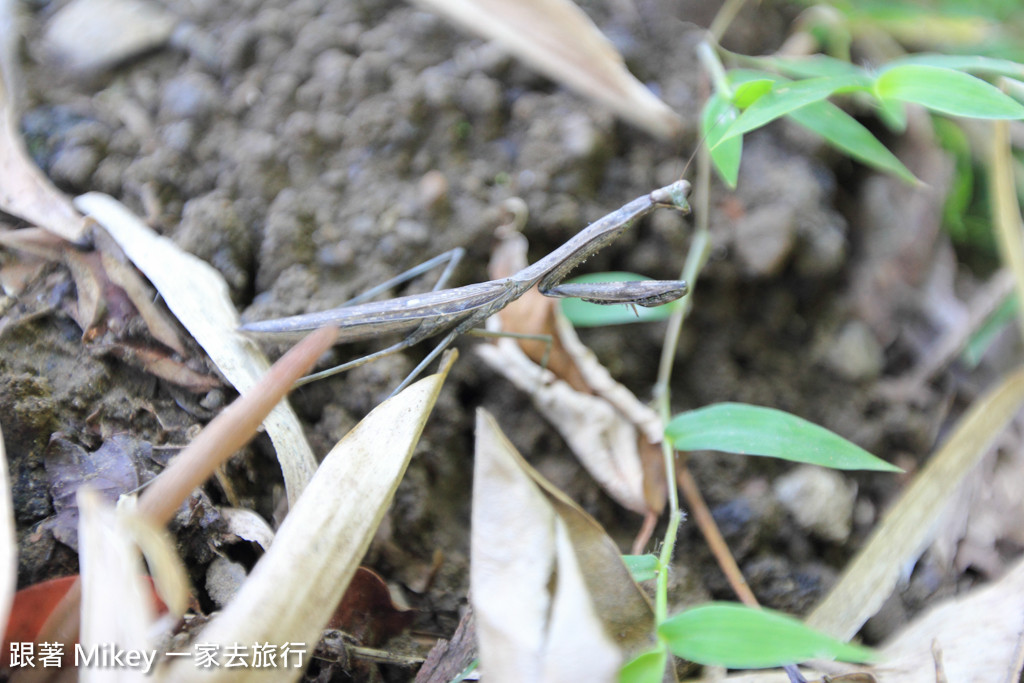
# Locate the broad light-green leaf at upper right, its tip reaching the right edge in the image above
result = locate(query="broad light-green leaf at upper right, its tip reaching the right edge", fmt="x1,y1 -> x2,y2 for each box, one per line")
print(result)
874,65 -> 1024,119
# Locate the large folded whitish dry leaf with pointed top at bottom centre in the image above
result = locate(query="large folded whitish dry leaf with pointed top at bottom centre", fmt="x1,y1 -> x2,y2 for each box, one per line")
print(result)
470,411 -> 654,681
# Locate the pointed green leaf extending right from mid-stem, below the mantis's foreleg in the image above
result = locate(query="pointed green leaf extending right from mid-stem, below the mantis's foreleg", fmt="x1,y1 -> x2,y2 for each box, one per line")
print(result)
665,403 -> 902,472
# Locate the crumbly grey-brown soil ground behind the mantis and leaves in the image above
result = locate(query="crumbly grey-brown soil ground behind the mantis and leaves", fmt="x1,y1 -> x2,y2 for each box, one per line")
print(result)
0,0 -> 1011,680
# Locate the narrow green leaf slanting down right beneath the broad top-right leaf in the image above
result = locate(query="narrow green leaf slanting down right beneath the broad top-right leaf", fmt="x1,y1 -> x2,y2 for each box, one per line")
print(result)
790,102 -> 918,183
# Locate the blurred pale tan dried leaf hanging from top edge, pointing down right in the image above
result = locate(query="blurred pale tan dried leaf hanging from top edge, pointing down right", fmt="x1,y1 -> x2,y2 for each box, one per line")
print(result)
405,0 -> 682,138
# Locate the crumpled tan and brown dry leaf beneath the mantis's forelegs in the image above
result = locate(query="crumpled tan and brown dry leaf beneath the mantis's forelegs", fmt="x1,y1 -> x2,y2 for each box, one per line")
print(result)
476,228 -> 665,514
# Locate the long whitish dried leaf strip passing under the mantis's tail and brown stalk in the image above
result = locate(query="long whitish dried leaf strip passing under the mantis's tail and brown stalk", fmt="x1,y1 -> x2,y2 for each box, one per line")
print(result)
75,193 -> 316,503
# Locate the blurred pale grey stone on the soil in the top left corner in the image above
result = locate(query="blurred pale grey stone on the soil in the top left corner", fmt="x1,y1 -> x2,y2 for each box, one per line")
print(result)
43,0 -> 178,72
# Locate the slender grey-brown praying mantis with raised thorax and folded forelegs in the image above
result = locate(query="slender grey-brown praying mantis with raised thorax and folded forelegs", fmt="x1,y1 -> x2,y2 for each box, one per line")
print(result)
241,180 -> 689,395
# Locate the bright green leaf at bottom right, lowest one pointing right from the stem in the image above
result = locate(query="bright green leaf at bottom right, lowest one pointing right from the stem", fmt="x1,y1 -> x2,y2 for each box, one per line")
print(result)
657,602 -> 877,669
